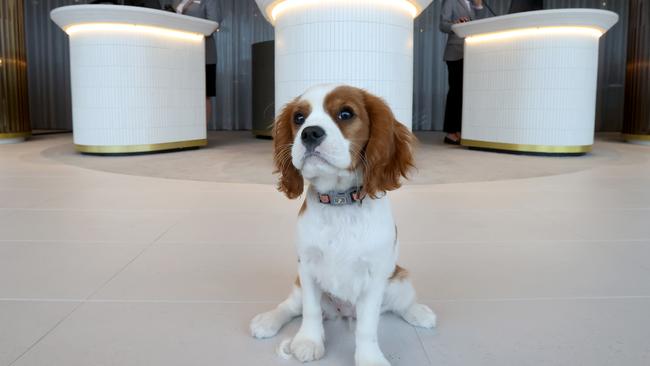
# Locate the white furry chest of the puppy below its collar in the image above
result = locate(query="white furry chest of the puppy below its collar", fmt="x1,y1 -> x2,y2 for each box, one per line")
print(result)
297,194 -> 398,304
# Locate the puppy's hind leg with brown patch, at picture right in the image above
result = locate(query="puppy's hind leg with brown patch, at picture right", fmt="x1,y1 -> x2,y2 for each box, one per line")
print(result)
382,266 -> 436,328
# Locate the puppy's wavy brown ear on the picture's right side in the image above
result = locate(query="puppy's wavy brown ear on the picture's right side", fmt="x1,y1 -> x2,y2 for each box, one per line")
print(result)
363,91 -> 416,198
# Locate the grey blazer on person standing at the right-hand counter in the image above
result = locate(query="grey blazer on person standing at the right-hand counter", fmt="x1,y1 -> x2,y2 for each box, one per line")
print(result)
440,0 -> 490,61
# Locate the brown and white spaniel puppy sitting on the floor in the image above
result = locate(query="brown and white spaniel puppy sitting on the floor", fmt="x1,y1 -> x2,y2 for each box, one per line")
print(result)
250,85 -> 436,366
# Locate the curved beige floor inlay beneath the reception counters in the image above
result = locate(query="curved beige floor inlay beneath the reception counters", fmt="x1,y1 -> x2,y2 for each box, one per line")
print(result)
43,132 -> 619,184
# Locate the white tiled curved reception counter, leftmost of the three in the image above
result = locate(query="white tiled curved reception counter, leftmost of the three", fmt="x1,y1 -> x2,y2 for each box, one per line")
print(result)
50,5 -> 217,154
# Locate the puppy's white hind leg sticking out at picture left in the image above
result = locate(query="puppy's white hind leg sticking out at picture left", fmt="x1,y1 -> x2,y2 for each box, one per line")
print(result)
250,281 -> 302,338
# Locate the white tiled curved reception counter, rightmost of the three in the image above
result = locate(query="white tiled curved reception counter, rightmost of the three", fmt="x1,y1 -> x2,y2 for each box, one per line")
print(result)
453,9 -> 618,154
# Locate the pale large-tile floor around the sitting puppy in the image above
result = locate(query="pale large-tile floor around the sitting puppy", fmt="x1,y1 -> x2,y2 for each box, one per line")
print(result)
0,135 -> 650,366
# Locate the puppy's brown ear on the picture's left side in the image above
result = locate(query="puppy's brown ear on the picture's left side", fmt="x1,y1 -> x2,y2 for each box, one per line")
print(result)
273,100 -> 305,199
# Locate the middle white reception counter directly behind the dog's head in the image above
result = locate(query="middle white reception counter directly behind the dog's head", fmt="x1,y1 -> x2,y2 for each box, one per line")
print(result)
256,0 -> 432,127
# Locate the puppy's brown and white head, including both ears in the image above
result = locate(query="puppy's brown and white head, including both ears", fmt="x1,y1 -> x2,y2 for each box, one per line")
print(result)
274,85 -> 415,198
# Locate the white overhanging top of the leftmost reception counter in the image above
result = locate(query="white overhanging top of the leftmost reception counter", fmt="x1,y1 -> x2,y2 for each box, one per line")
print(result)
50,5 -> 218,36
